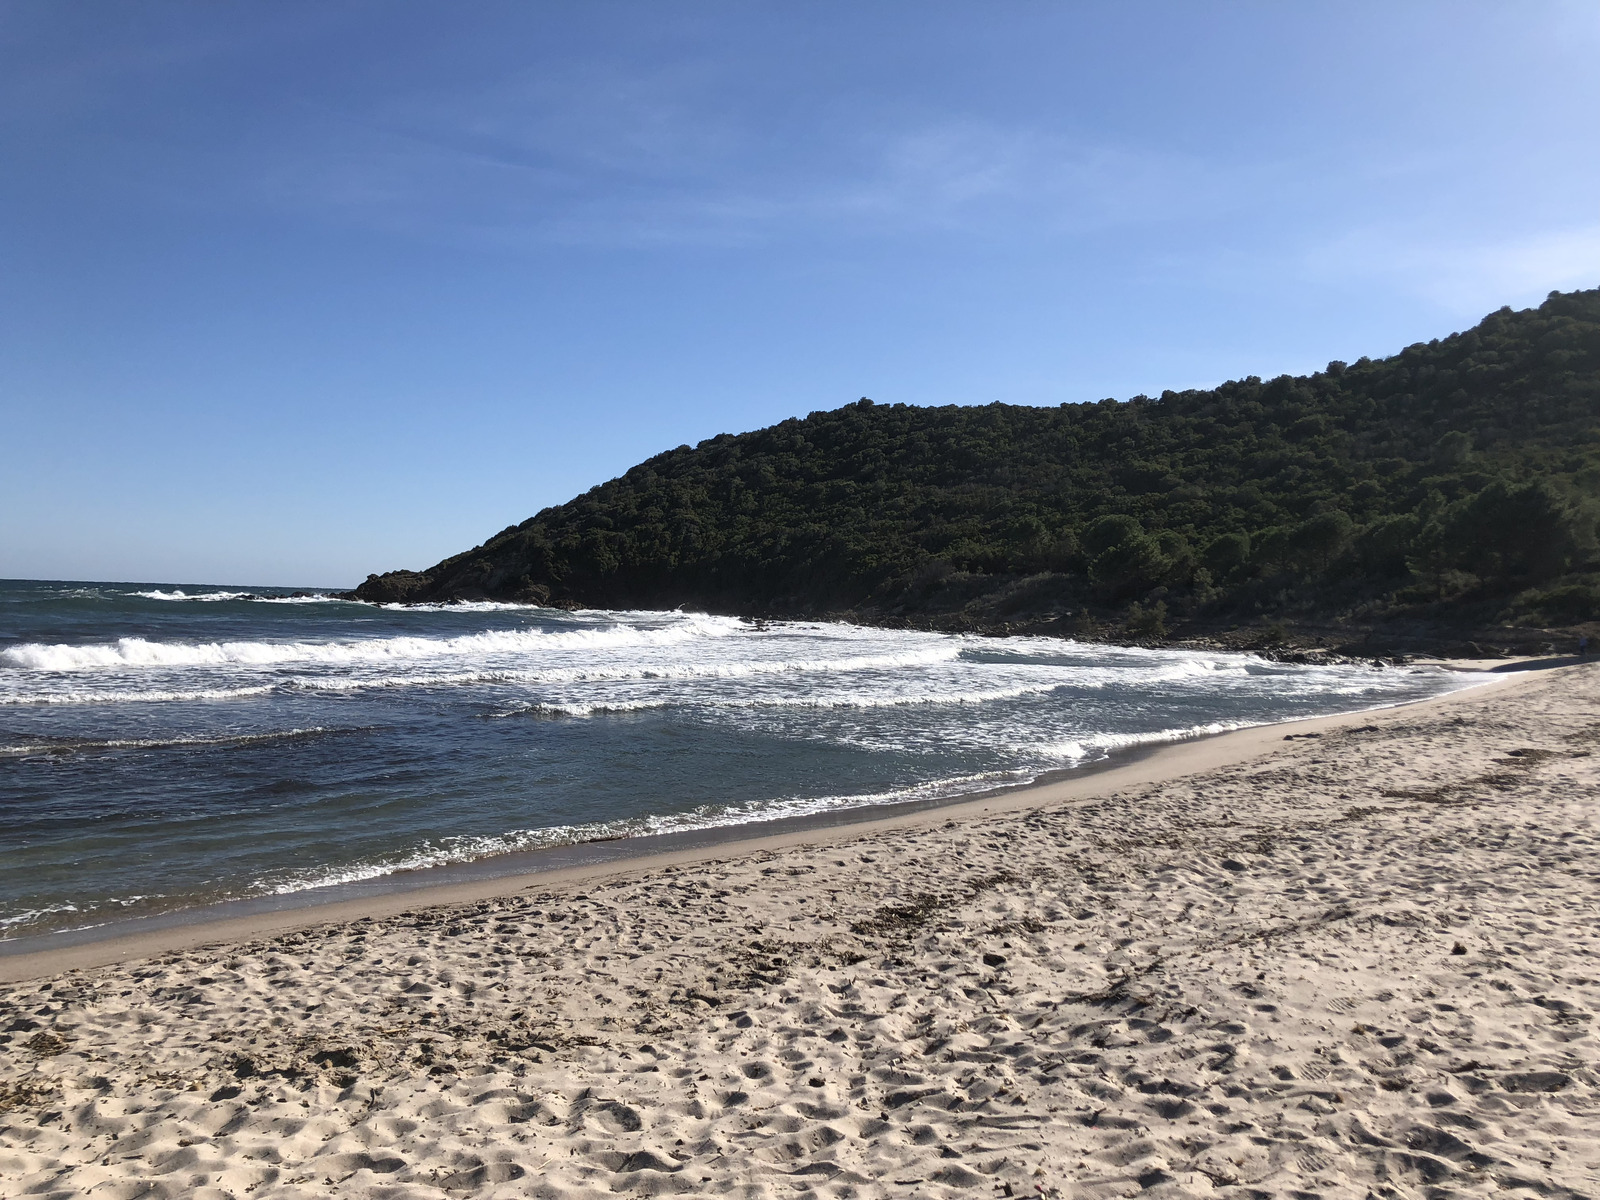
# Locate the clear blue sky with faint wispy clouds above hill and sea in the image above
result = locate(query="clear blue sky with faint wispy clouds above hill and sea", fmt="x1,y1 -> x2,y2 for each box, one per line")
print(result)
0,0 -> 1600,586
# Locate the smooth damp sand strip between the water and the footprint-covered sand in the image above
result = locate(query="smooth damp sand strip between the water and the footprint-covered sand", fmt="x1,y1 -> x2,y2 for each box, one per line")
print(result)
0,659 -> 1510,986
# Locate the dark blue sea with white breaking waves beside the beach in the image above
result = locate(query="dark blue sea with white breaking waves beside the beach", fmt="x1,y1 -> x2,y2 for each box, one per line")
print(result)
0,581 -> 1472,949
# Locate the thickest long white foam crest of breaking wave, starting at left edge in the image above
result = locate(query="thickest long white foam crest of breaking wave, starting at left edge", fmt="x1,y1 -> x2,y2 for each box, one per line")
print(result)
0,616 -> 741,670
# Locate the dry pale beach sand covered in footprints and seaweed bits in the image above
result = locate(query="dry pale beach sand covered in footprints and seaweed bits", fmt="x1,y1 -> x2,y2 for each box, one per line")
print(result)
0,666 -> 1600,1200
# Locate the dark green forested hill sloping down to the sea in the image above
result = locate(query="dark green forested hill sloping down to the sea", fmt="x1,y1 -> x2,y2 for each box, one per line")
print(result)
355,290 -> 1600,634
